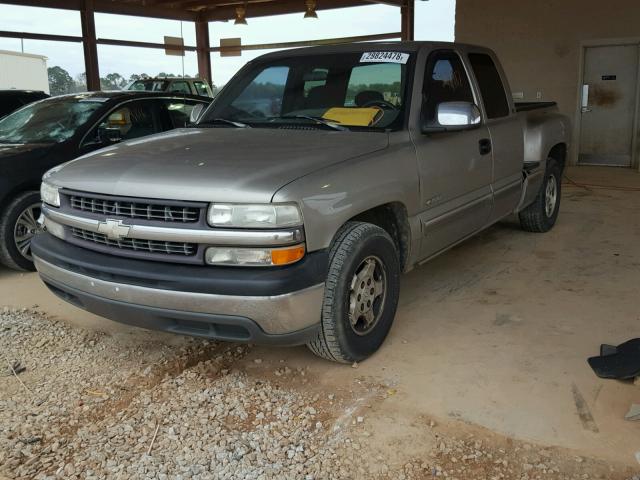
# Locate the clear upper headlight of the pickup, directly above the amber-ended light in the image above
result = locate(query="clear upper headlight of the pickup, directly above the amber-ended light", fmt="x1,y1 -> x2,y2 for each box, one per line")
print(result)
207,203 -> 302,228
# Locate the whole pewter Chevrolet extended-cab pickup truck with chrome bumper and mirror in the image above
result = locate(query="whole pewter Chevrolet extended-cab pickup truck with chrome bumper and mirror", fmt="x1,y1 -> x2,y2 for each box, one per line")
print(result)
32,42 -> 570,362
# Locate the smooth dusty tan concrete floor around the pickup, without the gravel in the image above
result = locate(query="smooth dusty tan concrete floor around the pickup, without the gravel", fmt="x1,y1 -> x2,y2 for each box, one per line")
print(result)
0,167 -> 640,466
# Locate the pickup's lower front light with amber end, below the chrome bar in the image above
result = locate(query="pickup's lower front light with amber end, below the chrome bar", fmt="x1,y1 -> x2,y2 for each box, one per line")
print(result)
205,245 -> 305,267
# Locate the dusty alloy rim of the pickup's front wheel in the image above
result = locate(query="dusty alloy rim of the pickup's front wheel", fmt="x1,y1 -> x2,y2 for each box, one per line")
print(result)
349,256 -> 387,335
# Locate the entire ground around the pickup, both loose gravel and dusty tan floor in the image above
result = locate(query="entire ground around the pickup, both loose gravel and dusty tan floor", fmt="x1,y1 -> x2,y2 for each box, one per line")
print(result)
0,167 -> 640,479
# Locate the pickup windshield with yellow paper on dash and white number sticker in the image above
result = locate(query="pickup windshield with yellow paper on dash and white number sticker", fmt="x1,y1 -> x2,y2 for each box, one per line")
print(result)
198,50 -> 412,131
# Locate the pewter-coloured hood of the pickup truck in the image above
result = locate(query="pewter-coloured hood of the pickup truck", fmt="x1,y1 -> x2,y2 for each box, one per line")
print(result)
47,128 -> 389,202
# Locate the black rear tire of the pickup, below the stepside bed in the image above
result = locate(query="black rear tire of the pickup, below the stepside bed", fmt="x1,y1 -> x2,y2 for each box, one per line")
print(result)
518,158 -> 562,233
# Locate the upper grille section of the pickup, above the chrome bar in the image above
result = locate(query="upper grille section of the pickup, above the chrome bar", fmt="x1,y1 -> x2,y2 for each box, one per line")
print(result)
69,194 -> 200,223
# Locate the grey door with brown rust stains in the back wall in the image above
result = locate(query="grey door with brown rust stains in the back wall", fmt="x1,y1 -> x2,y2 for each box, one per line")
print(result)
579,45 -> 638,167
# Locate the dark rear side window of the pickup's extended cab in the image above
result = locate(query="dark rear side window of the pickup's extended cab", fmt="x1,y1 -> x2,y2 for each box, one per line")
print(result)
469,53 -> 509,118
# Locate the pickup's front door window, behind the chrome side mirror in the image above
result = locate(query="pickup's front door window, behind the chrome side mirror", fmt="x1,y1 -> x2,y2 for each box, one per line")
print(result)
422,51 -> 474,122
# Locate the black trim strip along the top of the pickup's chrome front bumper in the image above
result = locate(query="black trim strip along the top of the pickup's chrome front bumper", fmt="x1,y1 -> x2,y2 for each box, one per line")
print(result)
31,233 -> 328,296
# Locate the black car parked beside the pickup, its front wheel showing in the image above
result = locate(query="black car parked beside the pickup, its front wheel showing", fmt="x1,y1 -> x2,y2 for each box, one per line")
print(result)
0,92 -> 211,270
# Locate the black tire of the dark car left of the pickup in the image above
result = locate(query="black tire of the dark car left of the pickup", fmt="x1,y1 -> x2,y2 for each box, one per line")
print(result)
0,192 -> 40,271
